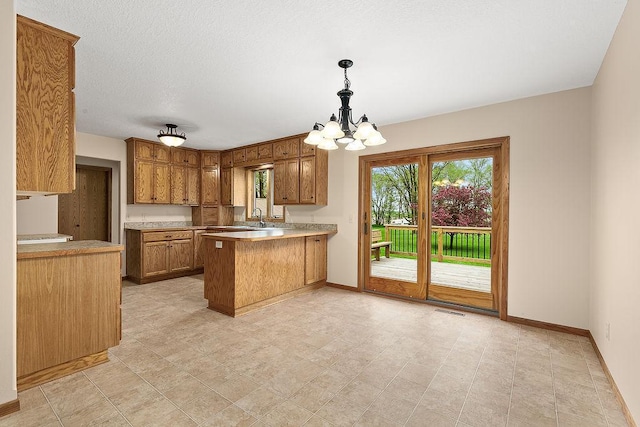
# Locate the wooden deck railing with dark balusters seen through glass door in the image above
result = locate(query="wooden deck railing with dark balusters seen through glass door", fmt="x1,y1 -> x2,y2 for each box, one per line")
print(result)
384,224 -> 491,264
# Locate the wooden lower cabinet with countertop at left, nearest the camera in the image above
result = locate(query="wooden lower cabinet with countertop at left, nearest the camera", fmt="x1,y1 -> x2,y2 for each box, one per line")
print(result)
16,240 -> 123,391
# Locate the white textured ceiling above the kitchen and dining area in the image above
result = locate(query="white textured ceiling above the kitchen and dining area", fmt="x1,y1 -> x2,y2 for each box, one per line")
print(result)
17,0 -> 626,149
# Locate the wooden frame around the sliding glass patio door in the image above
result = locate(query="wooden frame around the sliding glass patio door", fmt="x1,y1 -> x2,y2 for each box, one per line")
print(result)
357,136 -> 510,320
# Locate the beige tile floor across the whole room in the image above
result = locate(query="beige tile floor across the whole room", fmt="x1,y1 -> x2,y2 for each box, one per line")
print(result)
0,275 -> 627,427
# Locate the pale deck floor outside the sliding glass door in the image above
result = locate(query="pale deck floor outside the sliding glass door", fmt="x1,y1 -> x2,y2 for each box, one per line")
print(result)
371,257 -> 491,292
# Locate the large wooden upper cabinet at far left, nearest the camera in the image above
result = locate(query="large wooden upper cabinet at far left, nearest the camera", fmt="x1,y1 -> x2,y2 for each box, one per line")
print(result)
16,15 -> 79,194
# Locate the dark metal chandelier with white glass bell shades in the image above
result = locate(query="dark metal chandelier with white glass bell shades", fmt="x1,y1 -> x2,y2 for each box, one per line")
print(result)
304,59 -> 387,151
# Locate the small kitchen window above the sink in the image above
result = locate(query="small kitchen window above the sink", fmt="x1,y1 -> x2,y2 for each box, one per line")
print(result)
247,165 -> 284,222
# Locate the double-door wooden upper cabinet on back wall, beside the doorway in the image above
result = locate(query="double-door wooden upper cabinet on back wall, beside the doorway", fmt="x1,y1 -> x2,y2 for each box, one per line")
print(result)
126,138 -> 171,204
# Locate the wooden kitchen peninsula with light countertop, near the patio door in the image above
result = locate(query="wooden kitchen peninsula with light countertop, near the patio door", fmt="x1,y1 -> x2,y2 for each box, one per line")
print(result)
203,229 -> 335,317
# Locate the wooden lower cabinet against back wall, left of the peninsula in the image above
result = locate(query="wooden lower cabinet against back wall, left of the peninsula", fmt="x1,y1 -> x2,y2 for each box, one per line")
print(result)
126,230 -> 195,283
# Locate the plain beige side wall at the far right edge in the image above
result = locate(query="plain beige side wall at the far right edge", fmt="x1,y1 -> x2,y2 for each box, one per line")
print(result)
589,0 -> 640,421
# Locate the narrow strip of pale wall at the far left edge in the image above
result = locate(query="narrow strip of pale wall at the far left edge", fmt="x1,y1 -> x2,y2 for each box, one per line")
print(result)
0,0 -> 18,404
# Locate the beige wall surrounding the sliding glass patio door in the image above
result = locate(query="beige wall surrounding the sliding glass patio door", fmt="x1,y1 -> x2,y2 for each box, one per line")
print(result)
310,88 -> 591,328
